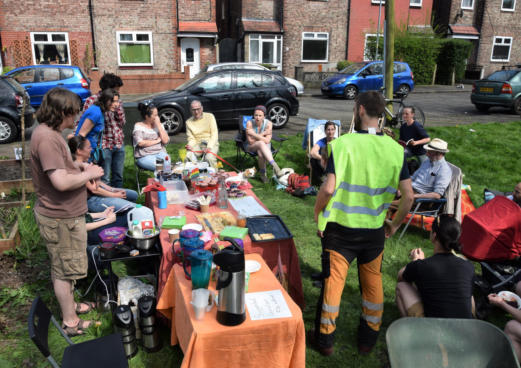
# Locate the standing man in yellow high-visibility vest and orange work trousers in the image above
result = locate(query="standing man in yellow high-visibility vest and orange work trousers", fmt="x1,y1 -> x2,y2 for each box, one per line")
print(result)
308,92 -> 413,355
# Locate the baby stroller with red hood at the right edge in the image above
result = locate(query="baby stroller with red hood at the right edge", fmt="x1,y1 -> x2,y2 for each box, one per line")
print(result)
460,196 -> 521,318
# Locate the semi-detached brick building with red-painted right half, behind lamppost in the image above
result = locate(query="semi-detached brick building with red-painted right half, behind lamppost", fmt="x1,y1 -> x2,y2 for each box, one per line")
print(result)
217,0 -> 433,75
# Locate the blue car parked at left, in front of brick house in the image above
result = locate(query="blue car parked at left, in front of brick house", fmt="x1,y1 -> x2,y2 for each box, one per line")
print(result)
5,64 -> 91,108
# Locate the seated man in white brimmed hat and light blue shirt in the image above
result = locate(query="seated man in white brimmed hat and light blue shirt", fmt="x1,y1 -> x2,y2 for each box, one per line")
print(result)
411,138 -> 452,199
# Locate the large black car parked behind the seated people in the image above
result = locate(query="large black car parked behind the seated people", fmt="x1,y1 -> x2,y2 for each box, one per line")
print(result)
142,69 -> 299,134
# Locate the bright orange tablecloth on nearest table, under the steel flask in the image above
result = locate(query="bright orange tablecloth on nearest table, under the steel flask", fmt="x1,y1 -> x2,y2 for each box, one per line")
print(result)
157,254 -> 306,368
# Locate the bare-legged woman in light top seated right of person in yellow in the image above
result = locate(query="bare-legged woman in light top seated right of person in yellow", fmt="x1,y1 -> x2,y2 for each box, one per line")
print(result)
246,105 -> 282,183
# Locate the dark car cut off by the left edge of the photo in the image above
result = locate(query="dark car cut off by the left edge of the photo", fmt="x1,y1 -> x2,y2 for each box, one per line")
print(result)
0,75 -> 35,143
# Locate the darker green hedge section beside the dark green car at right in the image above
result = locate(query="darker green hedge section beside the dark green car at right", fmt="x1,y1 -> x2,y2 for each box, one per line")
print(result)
436,38 -> 472,84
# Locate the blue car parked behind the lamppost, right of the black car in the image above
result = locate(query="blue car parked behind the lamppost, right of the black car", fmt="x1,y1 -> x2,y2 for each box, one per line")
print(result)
320,61 -> 414,100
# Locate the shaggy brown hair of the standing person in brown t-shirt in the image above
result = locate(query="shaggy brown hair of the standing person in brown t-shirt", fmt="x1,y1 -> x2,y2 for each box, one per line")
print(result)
36,87 -> 80,130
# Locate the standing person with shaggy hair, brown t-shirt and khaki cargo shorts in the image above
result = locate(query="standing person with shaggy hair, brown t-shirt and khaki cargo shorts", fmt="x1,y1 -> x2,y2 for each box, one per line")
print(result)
31,88 -> 103,336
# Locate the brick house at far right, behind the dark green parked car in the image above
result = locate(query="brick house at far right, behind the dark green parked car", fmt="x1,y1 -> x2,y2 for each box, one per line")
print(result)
433,0 -> 521,79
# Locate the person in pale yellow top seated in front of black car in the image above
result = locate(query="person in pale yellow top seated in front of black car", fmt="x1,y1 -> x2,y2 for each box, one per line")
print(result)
186,100 -> 219,168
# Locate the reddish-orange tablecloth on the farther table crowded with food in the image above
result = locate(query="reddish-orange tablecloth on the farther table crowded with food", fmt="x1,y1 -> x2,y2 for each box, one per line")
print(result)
145,179 -> 304,308
